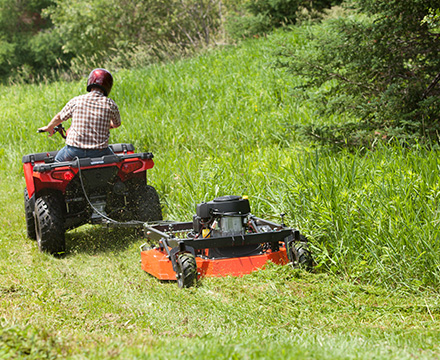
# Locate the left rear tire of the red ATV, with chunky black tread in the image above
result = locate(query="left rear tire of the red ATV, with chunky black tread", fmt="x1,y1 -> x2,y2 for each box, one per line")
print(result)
35,194 -> 66,255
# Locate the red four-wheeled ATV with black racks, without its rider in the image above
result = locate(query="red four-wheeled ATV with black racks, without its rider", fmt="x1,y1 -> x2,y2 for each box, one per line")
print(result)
22,126 -> 162,255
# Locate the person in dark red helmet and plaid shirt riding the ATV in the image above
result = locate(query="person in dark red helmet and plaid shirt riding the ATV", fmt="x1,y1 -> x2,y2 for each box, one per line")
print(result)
38,69 -> 121,161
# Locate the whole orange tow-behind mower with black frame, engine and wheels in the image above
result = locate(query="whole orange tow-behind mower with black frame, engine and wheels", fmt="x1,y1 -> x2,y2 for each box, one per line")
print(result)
141,195 -> 313,288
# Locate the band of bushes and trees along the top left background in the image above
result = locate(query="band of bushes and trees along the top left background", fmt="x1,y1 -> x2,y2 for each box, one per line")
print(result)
0,0 -> 341,81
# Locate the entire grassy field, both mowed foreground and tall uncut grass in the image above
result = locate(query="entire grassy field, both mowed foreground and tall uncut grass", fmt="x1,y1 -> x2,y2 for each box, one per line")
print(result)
0,27 -> 440,359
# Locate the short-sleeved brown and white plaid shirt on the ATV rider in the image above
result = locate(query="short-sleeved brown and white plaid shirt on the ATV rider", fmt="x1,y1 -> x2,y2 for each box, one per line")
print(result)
60,91 -> 121,149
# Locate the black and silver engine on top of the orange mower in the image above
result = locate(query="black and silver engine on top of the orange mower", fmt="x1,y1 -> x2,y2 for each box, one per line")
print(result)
193,195 -> 251,238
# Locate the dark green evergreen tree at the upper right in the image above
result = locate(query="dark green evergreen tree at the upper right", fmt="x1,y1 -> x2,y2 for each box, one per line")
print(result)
280,0 -> 440,145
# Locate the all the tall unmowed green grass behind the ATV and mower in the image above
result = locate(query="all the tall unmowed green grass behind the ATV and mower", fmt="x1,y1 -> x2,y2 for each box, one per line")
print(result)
0,29 -> 440,289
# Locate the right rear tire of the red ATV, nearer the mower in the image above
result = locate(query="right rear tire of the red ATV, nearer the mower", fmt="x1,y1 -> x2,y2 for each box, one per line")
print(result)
132,185 -> 162,221
